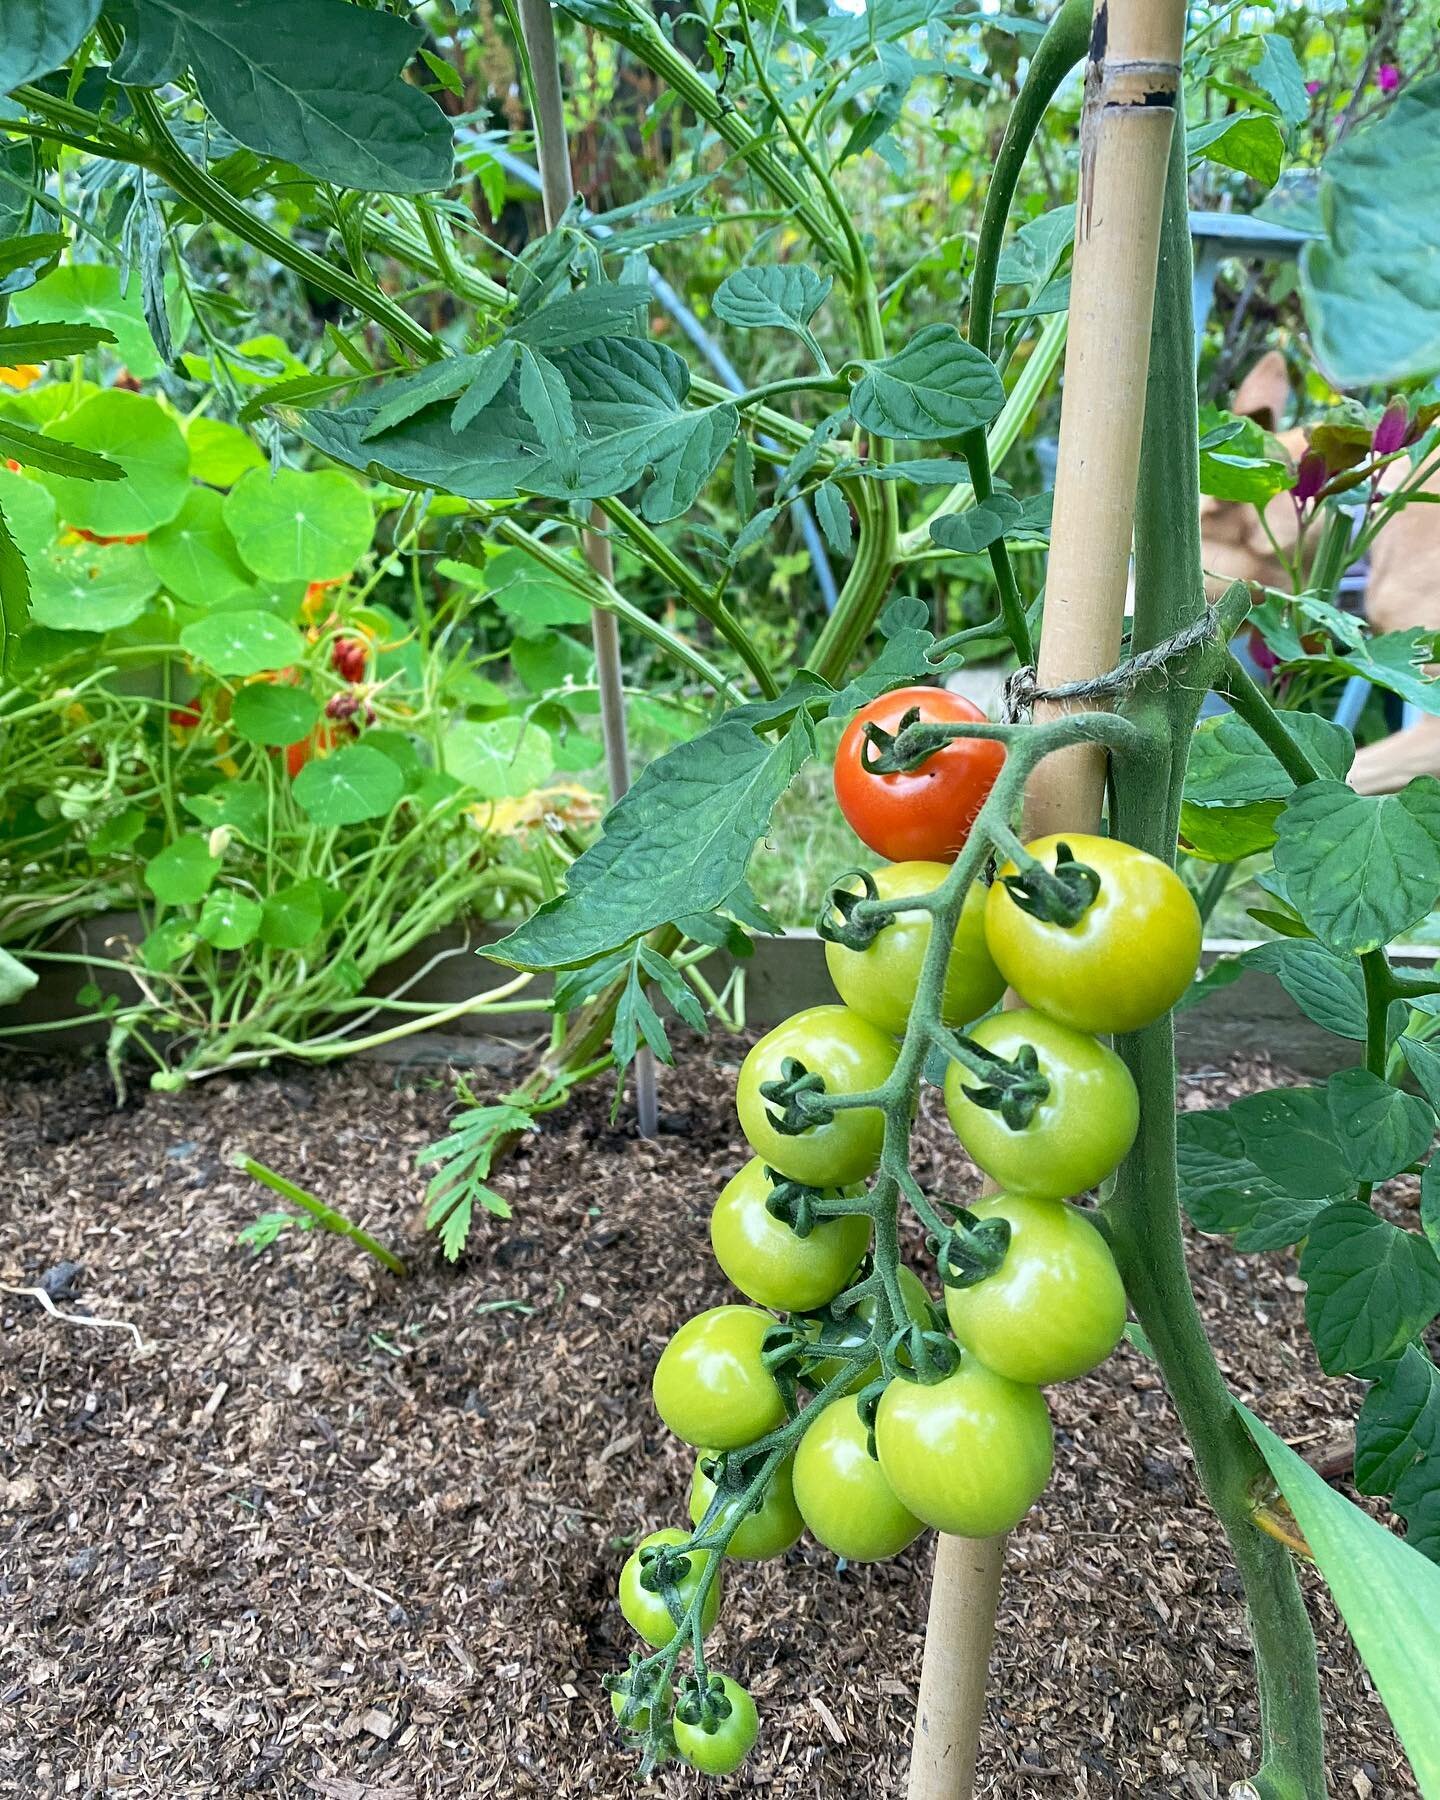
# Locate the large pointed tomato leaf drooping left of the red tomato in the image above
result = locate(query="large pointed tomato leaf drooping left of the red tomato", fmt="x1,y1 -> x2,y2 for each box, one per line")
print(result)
490,711 -> 815,968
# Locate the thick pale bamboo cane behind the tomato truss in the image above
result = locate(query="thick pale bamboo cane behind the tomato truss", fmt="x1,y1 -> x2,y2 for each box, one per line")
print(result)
909,0 -> 1184,1800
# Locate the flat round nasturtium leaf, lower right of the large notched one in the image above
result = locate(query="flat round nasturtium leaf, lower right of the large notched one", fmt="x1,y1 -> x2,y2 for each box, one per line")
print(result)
225,468 -> 374,581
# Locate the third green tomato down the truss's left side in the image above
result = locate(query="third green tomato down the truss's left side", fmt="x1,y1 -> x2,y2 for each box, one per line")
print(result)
709,1156 -> 869,1312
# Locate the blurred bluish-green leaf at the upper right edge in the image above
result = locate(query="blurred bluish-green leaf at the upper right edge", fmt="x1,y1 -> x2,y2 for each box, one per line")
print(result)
1300,76 -> 1440,389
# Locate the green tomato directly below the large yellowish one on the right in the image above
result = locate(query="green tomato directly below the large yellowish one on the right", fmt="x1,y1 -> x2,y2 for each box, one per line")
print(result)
945,1010 -> 1139,1201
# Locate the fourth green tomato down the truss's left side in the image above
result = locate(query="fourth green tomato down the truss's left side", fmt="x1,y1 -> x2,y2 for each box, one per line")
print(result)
653,1307 -> 785,1451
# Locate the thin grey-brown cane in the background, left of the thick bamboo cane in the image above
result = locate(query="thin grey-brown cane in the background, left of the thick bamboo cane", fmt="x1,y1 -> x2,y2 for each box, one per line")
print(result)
520,0 -> 659,1138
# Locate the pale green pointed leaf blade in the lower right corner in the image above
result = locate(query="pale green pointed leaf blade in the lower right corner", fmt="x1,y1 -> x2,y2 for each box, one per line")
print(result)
1237,1402 -> 1440,1771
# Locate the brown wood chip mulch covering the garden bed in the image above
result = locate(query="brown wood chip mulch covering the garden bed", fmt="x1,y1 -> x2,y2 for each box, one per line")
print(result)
0,1040 -> 1418,1800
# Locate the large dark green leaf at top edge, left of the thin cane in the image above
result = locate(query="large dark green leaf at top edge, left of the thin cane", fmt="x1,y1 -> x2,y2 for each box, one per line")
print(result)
115,0 -> 454,194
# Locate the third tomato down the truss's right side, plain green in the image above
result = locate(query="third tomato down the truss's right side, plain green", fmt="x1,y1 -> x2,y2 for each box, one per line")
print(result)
945,1193 -> 1125,1388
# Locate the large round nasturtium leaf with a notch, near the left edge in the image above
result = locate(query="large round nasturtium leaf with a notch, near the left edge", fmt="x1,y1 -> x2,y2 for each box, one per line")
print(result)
43,389 -> 191,538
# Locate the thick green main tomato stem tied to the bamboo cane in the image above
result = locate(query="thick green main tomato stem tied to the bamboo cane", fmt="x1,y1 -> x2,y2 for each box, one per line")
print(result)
1103,121 -> 1327,1800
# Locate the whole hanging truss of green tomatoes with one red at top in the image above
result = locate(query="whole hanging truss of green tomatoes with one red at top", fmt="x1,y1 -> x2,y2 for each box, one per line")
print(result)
612,689 -> 1201,1773
